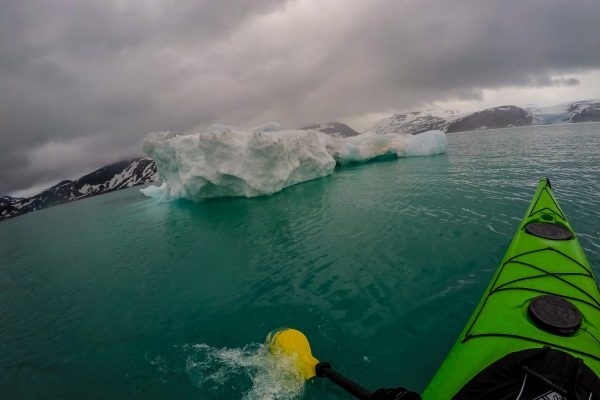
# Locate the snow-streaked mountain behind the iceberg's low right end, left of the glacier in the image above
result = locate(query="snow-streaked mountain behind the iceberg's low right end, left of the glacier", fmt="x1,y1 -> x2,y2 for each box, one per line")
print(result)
368,106 -> 533,135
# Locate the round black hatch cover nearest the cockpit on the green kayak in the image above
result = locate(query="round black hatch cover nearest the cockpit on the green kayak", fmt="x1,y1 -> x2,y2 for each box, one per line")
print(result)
528,295 -> 581,336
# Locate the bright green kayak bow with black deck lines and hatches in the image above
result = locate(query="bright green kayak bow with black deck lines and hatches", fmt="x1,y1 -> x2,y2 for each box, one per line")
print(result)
423,179 -> 600,400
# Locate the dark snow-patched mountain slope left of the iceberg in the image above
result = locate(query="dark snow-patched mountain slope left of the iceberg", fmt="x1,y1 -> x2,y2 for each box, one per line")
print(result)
0,158 -> 158,221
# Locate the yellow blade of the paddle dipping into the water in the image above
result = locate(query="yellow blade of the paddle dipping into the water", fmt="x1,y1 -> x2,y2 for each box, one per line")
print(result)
266,328 -> 319,380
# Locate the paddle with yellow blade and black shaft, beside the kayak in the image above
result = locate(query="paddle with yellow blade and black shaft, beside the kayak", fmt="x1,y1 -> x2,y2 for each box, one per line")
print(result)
266,328 -> 373,400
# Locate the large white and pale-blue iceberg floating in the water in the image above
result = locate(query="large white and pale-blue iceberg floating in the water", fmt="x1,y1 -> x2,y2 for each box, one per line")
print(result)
142,124 -> 447,201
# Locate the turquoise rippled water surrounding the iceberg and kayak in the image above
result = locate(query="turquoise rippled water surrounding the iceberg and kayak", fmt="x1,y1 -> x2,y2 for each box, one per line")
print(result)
0,124 -> 600,399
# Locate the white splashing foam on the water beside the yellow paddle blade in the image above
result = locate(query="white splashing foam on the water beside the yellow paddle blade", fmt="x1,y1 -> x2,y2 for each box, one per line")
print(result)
183,344 -> 305,400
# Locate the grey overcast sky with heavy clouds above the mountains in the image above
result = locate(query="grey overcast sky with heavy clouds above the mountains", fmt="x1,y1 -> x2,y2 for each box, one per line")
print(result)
0,0 -> 600,194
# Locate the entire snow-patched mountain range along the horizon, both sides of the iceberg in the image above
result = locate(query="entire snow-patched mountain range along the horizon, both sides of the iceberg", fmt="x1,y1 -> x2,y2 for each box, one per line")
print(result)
0,99 -> 600,221
